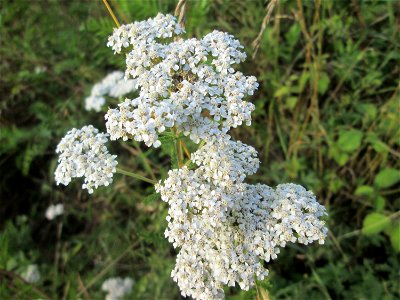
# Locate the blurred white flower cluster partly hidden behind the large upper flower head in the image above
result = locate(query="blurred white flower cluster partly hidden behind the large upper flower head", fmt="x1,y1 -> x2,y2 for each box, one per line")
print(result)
85,71 -> 137,112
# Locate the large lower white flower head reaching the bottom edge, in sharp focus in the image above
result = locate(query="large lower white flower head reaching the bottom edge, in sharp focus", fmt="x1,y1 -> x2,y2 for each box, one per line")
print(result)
156,144 -> 327,299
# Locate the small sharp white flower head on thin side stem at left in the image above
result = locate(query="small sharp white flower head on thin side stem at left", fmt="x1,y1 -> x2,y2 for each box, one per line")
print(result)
55,125 -> 118,193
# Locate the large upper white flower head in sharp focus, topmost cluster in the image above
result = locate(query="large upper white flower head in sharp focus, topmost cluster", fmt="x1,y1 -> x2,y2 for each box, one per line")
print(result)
106,14 -> 258,147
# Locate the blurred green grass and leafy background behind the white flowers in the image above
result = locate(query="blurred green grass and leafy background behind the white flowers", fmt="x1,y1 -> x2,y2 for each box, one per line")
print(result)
0,0 -> 400,299
